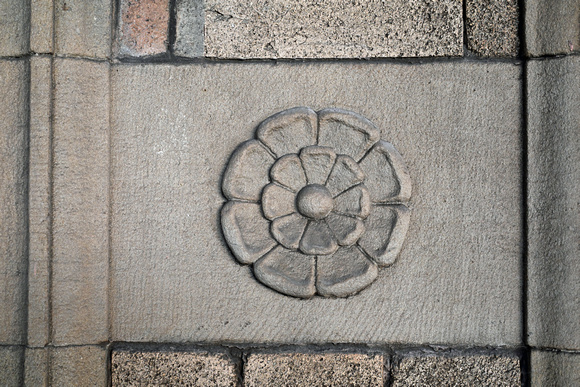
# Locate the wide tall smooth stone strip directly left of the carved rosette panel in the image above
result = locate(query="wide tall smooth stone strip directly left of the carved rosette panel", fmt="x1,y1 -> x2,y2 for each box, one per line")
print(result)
52,59 -> 109,345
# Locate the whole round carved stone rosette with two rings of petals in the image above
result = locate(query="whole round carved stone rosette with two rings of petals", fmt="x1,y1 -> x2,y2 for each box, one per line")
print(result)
222,107 -> 411,298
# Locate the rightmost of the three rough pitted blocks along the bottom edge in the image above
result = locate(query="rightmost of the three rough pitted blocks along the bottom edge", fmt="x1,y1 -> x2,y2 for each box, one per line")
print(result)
392,356 -> 521,387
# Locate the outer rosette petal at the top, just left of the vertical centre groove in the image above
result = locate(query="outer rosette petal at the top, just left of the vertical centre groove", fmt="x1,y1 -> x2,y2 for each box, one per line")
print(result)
257,107 -> 318,157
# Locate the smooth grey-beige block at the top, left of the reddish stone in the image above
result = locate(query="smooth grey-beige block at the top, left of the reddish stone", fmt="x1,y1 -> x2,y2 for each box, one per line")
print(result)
54,0 -> 113,58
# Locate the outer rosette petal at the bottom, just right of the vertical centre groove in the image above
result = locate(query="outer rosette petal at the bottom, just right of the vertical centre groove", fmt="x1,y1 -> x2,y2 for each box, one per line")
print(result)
316,246 -> 378,297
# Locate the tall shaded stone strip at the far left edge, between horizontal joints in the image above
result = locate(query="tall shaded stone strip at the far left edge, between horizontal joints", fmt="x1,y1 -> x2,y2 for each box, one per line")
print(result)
0,60 -> 29,344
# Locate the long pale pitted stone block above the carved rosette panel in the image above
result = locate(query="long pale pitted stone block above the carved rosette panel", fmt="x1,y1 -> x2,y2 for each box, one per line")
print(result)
204,0 -> 463,59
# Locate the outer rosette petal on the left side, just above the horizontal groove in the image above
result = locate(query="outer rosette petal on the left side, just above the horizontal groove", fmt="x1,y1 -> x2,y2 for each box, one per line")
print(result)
222,140 -> 274,202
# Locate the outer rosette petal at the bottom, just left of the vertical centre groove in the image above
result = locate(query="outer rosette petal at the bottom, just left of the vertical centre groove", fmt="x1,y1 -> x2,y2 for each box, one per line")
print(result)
254,246 -> 316,298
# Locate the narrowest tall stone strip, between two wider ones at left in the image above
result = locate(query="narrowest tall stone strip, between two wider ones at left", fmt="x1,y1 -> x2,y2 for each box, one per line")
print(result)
27,57 -> 52,346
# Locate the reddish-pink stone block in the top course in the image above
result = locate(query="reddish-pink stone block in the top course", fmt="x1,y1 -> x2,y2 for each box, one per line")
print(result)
116,0 -> 169,57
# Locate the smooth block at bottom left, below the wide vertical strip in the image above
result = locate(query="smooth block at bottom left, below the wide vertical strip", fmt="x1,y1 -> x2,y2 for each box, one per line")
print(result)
49,346 -> 108,387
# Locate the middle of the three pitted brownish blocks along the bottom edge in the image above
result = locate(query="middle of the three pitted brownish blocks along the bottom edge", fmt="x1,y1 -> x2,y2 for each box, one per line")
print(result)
244,353 -> 385,387
